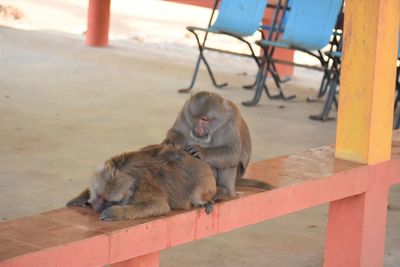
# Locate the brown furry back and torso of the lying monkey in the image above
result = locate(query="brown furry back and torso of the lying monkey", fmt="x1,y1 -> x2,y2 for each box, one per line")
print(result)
119,149 -> 216,209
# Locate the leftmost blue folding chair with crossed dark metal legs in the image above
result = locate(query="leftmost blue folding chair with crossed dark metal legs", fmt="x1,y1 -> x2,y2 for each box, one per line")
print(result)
179,0 -> 267,92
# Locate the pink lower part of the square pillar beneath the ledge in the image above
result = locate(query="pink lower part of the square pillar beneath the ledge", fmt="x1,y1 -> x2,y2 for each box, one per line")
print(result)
324,175 -> 388,267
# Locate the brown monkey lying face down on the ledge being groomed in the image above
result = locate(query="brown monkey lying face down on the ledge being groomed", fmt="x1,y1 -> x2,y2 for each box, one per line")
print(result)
67,145 -> 217,221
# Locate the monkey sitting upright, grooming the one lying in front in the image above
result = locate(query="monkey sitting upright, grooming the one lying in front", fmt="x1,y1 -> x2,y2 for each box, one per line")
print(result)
163,91 -> 271,200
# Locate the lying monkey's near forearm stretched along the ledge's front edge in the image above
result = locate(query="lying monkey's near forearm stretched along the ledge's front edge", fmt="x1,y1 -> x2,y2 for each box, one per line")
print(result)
100,197 -> 171,221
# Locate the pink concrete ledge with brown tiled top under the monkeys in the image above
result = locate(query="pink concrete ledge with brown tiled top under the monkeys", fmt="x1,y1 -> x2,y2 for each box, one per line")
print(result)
0,132 -> 400,267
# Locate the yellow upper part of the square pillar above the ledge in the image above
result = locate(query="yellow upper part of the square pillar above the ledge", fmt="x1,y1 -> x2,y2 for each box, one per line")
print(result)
335,0 -> 400,164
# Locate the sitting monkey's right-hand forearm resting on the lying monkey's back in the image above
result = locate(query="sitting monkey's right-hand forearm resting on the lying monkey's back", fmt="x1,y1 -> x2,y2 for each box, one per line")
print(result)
185,145 -> 239,169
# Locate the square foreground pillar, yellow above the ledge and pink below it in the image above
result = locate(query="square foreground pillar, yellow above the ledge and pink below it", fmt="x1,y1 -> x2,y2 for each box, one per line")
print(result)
324,0 -> 400,267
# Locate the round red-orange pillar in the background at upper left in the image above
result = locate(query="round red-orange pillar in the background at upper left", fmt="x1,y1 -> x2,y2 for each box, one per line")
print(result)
86,0 -> 111,46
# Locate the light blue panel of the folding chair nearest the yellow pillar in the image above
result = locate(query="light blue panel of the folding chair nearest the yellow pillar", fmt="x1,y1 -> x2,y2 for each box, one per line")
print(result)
281,0 -> 342,50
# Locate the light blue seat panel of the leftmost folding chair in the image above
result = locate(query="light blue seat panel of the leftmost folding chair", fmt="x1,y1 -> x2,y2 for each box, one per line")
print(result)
210,0 -> 267,37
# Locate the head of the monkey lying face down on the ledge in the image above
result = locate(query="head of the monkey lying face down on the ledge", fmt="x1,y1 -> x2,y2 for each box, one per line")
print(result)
89,164 -> 133,212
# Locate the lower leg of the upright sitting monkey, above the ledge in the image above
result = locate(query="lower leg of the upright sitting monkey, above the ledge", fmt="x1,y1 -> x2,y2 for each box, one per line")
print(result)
214,167 -> 237,200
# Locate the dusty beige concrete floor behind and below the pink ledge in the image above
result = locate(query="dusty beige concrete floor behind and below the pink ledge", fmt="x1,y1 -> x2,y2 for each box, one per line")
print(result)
0,8 -> 400,267
